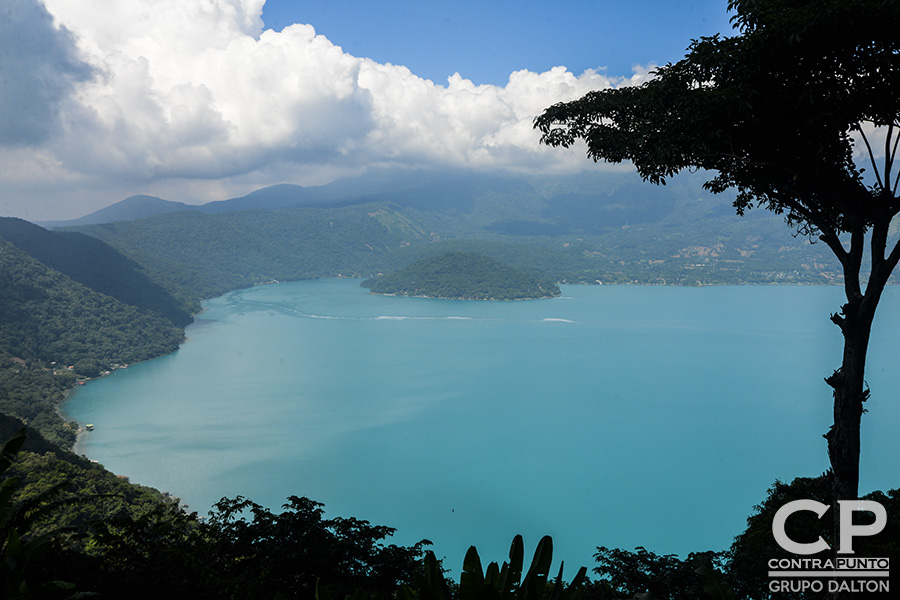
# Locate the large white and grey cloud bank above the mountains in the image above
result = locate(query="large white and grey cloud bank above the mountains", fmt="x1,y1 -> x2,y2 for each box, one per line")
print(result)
0,0 -> 647,219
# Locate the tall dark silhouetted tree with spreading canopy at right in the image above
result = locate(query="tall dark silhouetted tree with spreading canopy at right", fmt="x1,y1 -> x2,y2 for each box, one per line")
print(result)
535,0 -> 900,510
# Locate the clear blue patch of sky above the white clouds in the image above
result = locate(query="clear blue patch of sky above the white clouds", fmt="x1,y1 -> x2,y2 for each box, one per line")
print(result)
263,0 -> 731,85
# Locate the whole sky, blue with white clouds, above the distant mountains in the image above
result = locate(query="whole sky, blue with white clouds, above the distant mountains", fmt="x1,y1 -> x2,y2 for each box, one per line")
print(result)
0,0 -> 732,220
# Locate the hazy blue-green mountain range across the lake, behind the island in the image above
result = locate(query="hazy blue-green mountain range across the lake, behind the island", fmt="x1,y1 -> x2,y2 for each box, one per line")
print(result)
29,169 -> 838,297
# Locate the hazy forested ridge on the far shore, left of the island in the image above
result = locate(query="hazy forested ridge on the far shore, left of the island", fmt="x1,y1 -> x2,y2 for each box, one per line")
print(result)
68,205 -> 426,299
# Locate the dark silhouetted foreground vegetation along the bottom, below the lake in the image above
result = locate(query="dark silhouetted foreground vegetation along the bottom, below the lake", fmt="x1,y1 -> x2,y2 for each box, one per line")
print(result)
0,421 -> 900,600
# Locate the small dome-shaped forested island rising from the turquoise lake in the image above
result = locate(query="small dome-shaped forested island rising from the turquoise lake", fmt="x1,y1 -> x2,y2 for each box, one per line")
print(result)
360,252 -> 560,300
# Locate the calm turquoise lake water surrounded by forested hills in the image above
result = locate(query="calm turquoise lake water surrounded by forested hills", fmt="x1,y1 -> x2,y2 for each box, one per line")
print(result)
65,280 -> 900,576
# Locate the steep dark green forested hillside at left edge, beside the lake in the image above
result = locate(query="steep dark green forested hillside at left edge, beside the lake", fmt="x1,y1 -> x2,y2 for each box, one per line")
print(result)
0,234 -> 183,447
